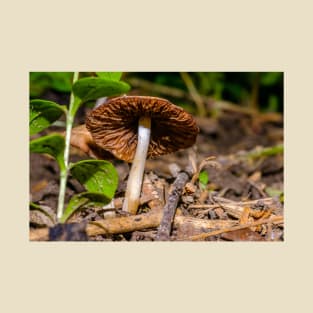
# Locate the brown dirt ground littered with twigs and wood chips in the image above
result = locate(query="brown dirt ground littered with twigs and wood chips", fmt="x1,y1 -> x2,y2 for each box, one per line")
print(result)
29,95 -> 284,241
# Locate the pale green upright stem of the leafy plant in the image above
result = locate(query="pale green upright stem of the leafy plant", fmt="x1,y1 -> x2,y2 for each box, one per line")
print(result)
57,72 -> 80,220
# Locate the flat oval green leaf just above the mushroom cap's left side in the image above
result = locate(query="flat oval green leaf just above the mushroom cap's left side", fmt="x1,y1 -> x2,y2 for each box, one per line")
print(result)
73,77 -> 130,102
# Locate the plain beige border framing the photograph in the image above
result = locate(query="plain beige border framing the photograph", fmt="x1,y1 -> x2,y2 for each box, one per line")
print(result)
0,0 -> 313,312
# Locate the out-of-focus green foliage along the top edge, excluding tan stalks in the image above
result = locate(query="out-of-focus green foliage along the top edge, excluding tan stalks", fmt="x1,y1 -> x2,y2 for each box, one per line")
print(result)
30,72 -> 284,112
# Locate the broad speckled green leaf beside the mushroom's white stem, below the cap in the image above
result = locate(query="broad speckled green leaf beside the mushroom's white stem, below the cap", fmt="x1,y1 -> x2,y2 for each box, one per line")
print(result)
70,160 -> 118,198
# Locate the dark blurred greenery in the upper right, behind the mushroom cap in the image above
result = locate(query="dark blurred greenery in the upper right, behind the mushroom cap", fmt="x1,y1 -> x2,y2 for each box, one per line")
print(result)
126,72 -> 284,114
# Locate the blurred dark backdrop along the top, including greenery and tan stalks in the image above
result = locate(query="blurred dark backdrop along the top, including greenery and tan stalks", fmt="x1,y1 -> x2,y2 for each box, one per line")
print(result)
30,72 -> 284,116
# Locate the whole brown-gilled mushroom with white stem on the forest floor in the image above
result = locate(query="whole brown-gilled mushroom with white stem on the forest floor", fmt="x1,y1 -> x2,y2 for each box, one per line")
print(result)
86,96 -> 199,214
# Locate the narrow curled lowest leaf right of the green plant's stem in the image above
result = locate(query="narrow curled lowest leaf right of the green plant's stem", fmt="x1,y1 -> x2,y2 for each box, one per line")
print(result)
60,192 -> 111,223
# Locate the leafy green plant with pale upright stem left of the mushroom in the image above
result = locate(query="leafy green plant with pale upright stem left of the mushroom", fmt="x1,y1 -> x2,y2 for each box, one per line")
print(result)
29,72 -> 130,222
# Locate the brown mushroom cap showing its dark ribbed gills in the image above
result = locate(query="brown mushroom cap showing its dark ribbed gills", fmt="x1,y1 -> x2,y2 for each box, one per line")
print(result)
86,96 -> 199,162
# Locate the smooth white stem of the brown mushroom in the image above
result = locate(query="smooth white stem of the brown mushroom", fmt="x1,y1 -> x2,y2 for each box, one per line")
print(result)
123,117 -> 151,214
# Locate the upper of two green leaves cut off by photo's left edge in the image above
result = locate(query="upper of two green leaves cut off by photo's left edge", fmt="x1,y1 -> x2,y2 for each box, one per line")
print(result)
29,99 -> 66,135
